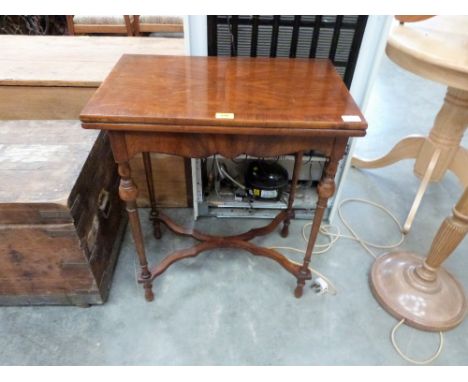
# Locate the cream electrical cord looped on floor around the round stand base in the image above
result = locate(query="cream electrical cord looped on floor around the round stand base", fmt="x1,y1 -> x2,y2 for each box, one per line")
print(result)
270,198 -> 444,365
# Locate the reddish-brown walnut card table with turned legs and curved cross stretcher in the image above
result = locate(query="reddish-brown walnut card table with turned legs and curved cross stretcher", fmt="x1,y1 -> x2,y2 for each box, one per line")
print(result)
80,55 -> 367,301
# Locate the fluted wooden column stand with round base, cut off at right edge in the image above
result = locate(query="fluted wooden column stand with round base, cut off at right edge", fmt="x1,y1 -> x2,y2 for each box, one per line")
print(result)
369,188 -> 468,331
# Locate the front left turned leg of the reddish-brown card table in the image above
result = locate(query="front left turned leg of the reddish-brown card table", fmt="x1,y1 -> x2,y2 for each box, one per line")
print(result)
119,162 -> 154,301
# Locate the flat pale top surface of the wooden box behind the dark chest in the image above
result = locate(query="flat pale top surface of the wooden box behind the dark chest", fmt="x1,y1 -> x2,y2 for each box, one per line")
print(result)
0,35 -> 184,87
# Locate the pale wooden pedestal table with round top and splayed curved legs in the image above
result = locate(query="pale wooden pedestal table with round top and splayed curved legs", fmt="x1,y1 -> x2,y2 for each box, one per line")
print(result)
351,16 -> 468,233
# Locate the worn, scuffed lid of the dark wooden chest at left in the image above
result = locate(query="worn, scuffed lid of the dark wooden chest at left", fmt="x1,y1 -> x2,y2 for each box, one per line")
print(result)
0,121 -> 98,224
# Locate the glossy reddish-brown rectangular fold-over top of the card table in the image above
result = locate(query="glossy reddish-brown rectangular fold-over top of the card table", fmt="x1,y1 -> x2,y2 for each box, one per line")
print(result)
81,55 -> 367,135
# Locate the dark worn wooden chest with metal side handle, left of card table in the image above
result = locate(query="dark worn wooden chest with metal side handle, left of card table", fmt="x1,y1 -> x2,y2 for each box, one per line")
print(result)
0,121 -> 126,305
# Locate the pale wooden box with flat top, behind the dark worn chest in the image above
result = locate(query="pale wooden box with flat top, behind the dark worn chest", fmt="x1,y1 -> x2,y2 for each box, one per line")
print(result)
0,35 -> 184,120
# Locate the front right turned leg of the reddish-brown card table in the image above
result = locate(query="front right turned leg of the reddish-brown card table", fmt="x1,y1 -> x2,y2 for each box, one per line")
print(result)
294,151 -> 339,298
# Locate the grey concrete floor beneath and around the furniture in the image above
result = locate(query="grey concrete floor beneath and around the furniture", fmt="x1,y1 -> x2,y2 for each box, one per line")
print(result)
0,58 -> 468,365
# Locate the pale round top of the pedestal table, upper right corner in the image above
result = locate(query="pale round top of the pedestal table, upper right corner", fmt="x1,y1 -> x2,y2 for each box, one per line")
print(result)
386,16 -> 468,91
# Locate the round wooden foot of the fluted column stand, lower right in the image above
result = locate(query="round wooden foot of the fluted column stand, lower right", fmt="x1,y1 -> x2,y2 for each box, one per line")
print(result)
369,252 -> 466,331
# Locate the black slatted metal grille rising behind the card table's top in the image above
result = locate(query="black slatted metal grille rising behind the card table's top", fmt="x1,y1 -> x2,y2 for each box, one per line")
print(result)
208,15 -> 367,89
